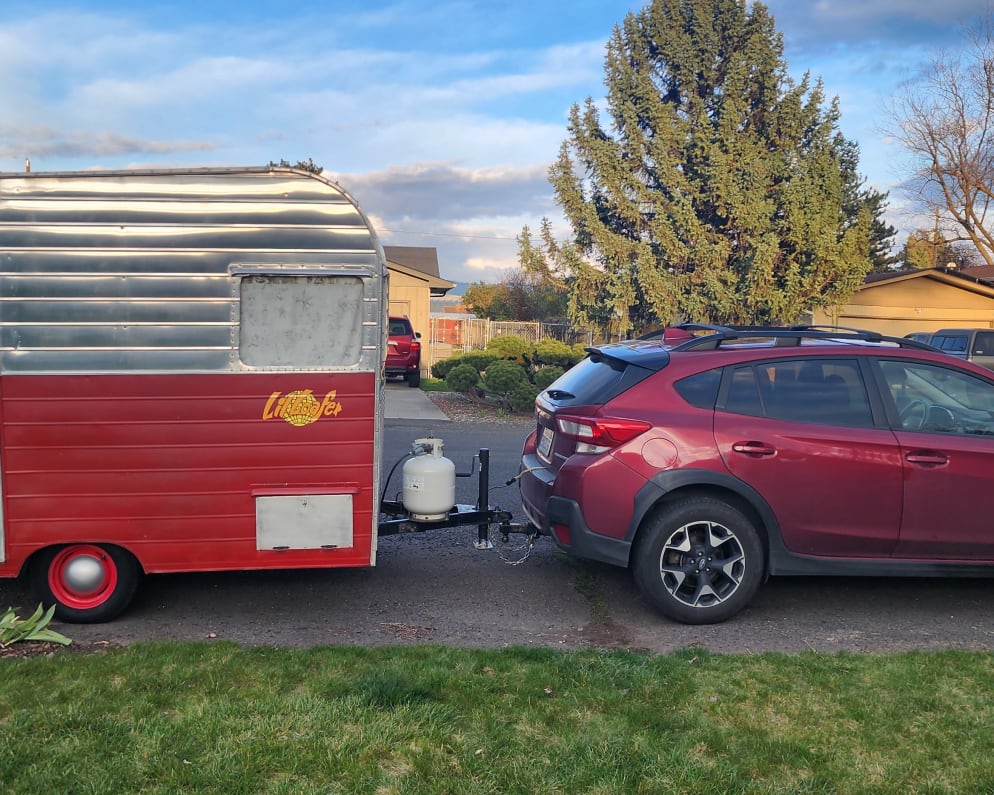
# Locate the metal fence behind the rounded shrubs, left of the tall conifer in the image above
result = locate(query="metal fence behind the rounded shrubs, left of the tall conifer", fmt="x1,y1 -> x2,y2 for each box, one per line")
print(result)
427,315 -> 595,368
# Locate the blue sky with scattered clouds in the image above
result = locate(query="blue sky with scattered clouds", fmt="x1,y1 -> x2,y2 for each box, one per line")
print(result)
0,0 -> 990,282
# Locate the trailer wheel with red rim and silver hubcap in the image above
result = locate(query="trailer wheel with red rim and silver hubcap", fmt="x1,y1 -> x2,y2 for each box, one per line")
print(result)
30,544 -> 142,624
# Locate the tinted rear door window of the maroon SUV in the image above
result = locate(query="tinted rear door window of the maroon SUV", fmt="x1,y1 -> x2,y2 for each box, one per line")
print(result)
725,358 -> 873,428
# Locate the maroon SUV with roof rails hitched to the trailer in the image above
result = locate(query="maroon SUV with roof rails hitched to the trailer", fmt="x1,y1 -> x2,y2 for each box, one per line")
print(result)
520,326 -> 994,624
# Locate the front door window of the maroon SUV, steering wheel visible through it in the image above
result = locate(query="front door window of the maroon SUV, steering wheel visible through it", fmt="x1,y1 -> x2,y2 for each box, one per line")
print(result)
879,359 -> 994,436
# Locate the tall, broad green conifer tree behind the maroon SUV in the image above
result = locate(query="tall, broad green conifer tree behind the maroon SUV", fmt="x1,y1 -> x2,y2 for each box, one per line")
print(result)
550,0 -> 880,334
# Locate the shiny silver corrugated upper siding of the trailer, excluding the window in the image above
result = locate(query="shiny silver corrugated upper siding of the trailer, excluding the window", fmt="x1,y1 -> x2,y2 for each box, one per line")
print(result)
0,169 -> 386,372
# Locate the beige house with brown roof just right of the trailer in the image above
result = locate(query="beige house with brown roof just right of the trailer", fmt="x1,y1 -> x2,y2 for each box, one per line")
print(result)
383,246 -> 456,377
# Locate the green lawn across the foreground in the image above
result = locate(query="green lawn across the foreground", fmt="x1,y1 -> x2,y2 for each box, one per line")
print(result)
0,643 -> 994,795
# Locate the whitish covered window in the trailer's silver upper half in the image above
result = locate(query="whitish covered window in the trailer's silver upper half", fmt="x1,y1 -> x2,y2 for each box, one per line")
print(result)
239,275 -> 364,367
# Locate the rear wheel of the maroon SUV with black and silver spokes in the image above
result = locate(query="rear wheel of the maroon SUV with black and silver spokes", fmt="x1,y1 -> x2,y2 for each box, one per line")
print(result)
633,497 -> 765,624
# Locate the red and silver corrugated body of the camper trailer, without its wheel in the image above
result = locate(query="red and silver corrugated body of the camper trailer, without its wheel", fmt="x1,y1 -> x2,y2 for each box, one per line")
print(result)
0,169 -> 387,574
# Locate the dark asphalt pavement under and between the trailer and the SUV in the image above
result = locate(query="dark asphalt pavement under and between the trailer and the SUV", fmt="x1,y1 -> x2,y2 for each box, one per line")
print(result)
0,384 -> 994,653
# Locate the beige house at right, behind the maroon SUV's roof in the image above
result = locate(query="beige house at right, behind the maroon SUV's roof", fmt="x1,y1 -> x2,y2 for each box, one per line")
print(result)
812,269 -> 994,337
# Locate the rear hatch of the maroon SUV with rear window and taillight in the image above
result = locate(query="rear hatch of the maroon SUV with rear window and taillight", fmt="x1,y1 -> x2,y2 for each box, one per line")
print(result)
535,341 -> 670,477
